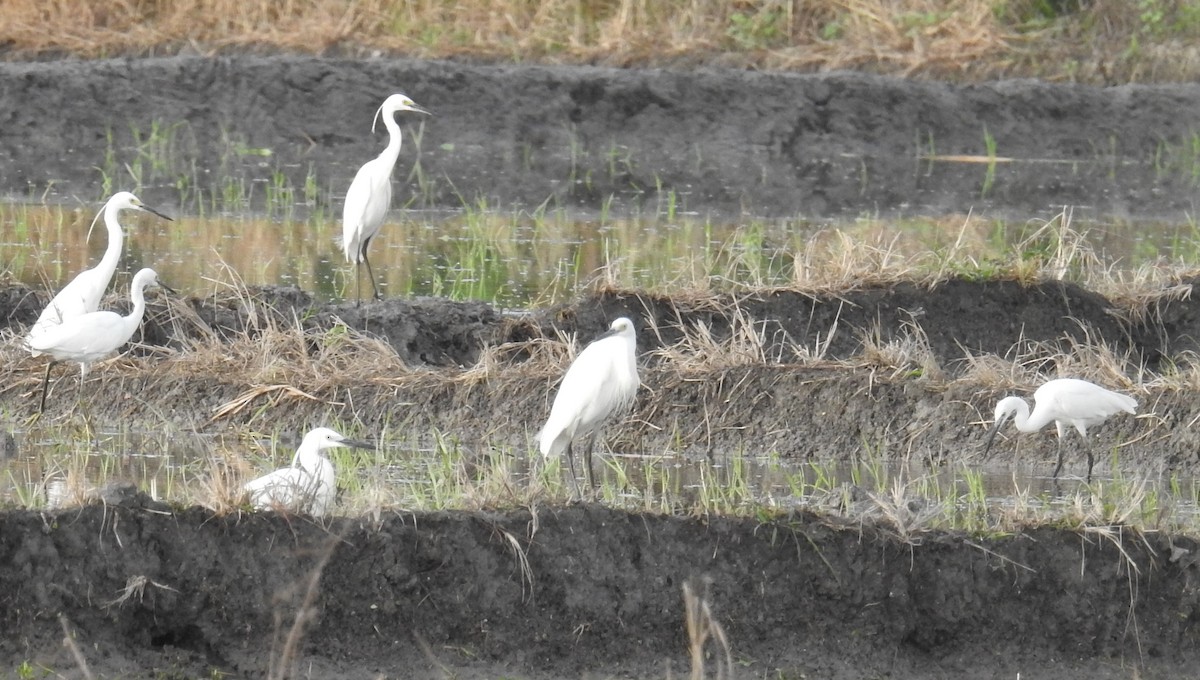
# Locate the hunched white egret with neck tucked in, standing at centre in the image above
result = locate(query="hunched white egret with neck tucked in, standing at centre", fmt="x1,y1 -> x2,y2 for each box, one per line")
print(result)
540,317 -> 640,498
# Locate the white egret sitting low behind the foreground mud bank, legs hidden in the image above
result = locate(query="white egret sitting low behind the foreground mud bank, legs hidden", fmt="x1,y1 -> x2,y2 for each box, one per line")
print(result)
242,427 -> 372,517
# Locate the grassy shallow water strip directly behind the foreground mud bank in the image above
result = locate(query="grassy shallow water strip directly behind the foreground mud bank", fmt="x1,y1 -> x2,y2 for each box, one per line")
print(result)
0,431 -> 1200,530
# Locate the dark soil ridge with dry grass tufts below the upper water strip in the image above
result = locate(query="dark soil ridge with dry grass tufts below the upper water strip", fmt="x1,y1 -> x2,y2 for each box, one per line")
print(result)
7,278 -> 1200,375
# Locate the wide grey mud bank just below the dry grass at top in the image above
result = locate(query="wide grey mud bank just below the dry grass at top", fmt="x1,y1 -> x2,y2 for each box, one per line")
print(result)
0,56 -> 1200,221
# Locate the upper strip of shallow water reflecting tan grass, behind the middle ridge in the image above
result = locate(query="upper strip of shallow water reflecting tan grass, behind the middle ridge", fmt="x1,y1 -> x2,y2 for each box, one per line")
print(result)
0,203 -> 1200,307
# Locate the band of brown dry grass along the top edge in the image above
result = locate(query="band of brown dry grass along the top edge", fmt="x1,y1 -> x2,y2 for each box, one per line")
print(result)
7,0 -> 1200,83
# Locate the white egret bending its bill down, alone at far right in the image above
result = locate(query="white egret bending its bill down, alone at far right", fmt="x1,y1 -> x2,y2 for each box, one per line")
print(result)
984,378 -> 1138,481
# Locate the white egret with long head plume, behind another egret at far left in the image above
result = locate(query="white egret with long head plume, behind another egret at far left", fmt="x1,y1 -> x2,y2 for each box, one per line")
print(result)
26,191 -> 170,345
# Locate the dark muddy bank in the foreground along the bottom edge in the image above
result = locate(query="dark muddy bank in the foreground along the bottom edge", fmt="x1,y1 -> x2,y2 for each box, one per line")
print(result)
0,497 -> 1200,679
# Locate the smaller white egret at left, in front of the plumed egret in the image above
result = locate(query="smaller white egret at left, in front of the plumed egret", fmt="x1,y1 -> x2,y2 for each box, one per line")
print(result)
26,269 -> 166,411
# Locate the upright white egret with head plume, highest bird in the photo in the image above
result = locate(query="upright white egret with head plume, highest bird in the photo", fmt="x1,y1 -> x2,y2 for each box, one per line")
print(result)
342,95 -> 430,305
